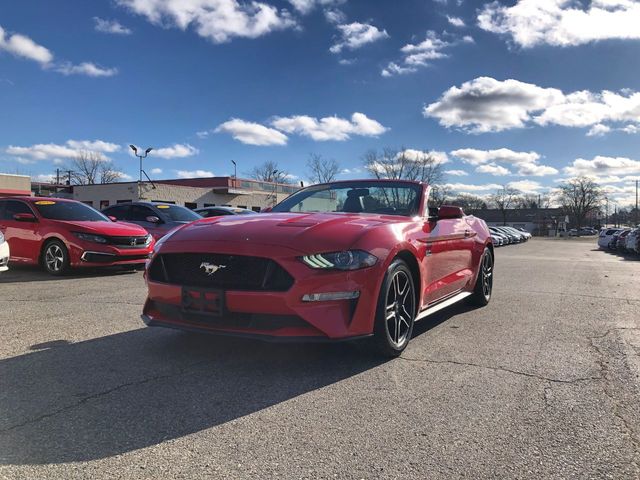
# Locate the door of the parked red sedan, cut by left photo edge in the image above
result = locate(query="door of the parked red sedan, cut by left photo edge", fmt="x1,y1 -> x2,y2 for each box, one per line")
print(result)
0,200 -> 41,261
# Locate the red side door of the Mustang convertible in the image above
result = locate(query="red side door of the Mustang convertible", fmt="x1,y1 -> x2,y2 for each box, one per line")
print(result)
422,206 -> 475,303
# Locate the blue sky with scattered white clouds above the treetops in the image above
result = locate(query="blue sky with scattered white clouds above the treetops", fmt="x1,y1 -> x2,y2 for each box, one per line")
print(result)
0,0 -> 640,205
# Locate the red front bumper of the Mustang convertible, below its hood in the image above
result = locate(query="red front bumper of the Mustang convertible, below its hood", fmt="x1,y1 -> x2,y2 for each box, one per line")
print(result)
142,243 -> 384,341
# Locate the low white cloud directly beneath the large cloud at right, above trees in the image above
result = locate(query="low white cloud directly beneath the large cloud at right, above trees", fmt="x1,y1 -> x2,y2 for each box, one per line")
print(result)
451,148 -> 558,177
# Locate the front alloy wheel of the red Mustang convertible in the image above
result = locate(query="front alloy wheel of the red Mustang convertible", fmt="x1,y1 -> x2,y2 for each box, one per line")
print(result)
385,270 -> 415,347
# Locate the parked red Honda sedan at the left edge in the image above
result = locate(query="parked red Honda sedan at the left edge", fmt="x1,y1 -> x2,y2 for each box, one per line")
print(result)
0,197 -> 155,275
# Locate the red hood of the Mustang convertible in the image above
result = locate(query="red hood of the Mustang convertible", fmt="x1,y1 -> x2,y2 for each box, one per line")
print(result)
162,213 -> 407,252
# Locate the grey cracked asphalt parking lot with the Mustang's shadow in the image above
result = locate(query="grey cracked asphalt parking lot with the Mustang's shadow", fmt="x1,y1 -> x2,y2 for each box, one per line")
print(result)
0,239 -> 640,479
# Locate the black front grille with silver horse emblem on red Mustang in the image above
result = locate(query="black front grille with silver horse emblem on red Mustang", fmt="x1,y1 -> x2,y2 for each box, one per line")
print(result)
149,253 -> 293,292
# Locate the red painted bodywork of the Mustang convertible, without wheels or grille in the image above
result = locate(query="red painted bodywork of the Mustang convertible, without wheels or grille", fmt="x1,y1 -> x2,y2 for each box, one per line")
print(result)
142,180 -> 493,340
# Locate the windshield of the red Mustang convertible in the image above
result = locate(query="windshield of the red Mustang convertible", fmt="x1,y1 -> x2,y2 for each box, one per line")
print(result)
272,180 -> 422,216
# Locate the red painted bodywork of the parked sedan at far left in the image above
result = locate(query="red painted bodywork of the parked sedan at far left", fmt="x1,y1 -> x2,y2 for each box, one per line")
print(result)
0,197 -> 155,267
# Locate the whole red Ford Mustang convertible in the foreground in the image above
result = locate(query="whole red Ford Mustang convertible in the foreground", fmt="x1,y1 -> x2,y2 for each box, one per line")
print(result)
142,180 -> 494,356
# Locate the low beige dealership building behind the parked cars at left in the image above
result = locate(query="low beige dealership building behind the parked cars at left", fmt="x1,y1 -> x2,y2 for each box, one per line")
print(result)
72,177 -> 300,211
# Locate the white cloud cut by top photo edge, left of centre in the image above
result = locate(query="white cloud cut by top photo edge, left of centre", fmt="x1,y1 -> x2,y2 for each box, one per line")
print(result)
117,0 -> 298,43
